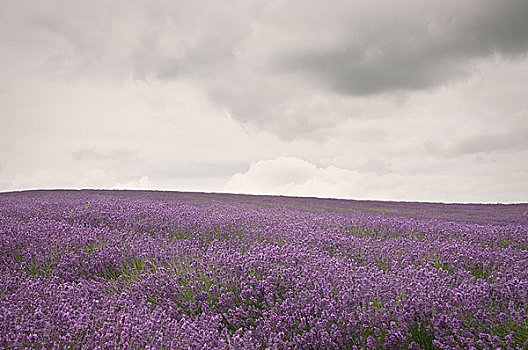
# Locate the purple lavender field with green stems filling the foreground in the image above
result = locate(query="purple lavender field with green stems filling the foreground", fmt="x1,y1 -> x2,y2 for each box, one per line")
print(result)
0,190 -> 528,349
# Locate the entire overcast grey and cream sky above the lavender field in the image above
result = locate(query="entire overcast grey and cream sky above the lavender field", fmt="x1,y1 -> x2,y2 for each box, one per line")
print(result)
0,0 -> 528,202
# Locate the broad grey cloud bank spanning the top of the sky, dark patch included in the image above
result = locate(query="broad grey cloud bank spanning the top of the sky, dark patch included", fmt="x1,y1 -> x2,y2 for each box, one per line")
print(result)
4,0 -> 528,141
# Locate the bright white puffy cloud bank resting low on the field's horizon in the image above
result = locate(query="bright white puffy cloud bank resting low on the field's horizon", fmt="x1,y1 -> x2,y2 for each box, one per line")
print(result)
224,157 -> 522,202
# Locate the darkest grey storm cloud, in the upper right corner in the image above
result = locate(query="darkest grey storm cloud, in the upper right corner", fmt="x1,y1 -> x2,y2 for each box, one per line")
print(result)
277,0 -> 528,95
